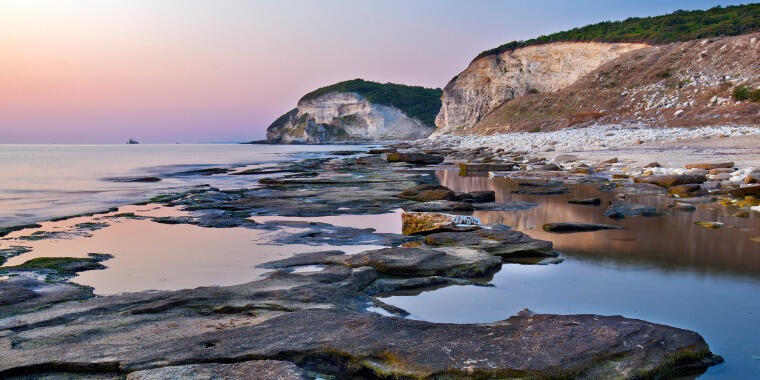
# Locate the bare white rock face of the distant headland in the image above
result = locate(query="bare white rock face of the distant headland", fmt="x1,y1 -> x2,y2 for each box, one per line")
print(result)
267,92 -> 435,144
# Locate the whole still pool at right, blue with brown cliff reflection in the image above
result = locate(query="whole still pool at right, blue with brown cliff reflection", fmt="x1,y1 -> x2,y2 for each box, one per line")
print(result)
383,170 -> 760,379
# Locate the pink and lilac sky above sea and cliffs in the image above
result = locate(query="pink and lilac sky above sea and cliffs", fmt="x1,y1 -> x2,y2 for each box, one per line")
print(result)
0,0 -> 747,144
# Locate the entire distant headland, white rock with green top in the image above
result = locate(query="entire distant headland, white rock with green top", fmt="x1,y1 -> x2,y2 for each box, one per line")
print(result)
267,79 -> 441,144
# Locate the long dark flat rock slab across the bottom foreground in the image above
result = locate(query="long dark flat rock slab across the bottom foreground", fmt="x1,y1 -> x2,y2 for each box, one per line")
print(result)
0,309 -> 720,379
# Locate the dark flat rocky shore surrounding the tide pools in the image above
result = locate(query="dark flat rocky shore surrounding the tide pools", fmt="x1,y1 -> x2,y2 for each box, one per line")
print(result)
0,144 -> 744,379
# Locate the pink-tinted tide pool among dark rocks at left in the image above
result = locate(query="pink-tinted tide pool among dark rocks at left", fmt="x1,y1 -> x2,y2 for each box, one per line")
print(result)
0,205 -> 381,295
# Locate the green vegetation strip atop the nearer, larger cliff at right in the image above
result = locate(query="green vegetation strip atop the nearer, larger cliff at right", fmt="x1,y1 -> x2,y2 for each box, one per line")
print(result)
475,3 -> 760,59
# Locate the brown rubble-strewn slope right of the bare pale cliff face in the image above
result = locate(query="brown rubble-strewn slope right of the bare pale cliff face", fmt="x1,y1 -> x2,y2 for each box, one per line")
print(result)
476,33 -> 760,134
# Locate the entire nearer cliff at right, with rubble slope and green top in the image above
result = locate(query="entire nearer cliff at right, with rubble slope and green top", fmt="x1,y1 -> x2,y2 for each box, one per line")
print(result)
435,4 -> 760,134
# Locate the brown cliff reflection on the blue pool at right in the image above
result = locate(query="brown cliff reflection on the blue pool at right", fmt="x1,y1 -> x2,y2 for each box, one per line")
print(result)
436,170 -> 760,277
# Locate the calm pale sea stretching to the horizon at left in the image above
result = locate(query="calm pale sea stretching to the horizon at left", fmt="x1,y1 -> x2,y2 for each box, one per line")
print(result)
0,144 -> 366,227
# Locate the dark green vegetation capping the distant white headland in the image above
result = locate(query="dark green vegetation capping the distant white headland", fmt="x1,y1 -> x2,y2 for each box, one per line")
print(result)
301,79 -> 443,126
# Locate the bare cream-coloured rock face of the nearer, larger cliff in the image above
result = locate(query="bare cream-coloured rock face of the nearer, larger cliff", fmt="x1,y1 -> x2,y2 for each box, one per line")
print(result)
435,42 -> 648,134
